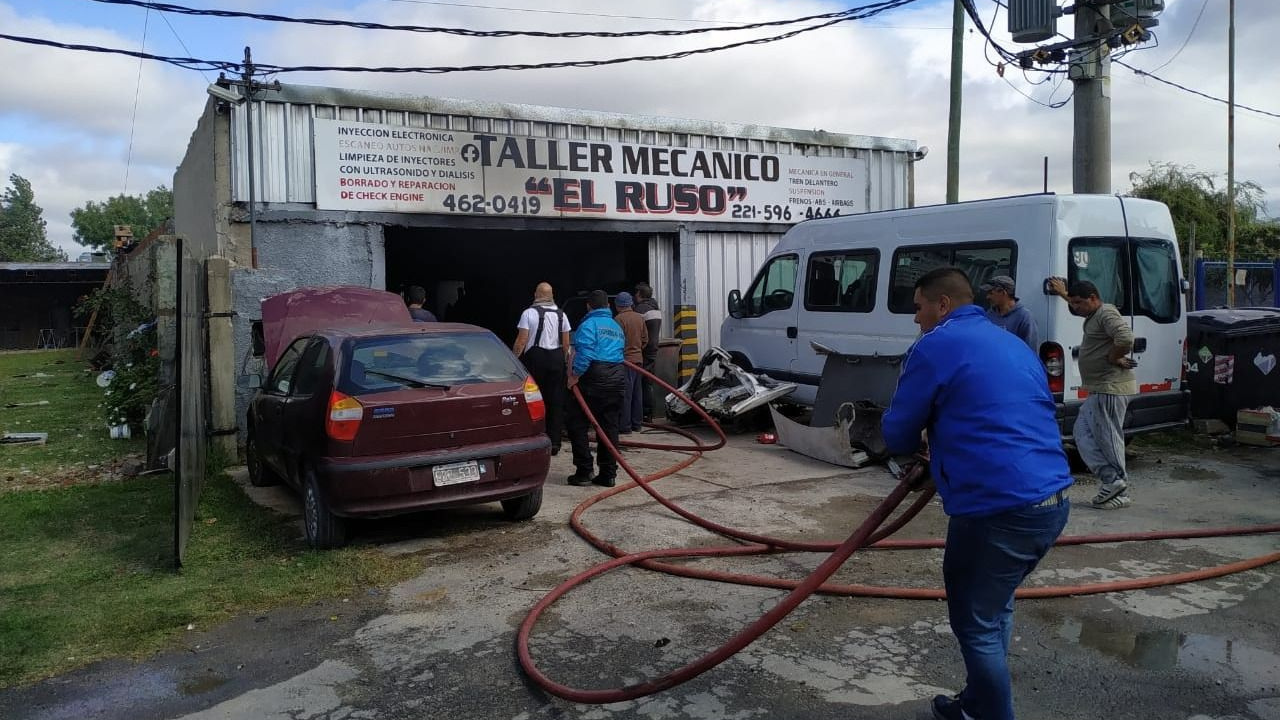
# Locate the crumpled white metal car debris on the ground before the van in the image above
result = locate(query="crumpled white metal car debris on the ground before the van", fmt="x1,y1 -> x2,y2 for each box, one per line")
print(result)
667,347 -> 796,420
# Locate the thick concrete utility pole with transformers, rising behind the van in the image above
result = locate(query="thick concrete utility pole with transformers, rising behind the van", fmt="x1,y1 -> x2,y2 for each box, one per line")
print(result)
1070,0 -> 1111,193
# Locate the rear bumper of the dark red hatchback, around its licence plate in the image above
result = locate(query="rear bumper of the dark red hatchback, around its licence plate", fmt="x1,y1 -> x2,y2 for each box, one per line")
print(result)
316,434 -> 550,518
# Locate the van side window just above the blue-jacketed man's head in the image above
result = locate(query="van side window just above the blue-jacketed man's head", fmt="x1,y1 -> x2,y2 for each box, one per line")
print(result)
888,240 -> 1018,315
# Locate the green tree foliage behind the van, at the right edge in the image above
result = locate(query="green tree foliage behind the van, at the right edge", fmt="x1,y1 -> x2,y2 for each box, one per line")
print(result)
1129,163 -> 1280,266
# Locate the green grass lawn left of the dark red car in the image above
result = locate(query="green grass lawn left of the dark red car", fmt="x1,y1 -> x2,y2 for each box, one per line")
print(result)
0,354 -> 422,687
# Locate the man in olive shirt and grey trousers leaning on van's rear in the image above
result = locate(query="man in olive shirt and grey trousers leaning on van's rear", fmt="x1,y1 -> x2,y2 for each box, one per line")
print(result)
1048,278 -> 1138,510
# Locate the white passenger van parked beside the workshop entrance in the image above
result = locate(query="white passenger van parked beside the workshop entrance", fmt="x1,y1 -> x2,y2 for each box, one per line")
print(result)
721,195 -> 1187,438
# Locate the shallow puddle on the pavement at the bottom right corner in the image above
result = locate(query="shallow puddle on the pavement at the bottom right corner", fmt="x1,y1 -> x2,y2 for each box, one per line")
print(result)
1059,619 -> 1280,693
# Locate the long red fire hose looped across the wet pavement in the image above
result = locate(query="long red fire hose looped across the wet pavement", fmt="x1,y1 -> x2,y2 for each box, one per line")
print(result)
516,363 -> 1280,703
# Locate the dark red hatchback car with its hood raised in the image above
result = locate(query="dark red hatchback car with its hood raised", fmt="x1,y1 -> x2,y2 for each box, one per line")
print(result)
244,288 -> 550,547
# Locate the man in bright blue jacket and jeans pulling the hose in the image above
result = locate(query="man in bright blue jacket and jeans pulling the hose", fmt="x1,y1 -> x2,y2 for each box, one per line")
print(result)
883,268 -> 1071,720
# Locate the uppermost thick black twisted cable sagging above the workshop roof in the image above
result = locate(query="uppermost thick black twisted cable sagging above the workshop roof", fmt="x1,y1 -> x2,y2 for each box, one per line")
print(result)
93,0 -> 901,38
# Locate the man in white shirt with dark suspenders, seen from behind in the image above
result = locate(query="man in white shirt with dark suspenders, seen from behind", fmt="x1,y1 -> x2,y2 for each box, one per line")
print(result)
511,283 -> 573,455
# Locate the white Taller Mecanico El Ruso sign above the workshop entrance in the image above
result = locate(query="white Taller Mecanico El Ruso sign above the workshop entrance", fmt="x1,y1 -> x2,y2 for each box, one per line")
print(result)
315,118 -> 867,224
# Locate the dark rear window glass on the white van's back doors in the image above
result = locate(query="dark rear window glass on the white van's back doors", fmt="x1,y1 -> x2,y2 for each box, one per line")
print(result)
1068,237 -> 1181,323
